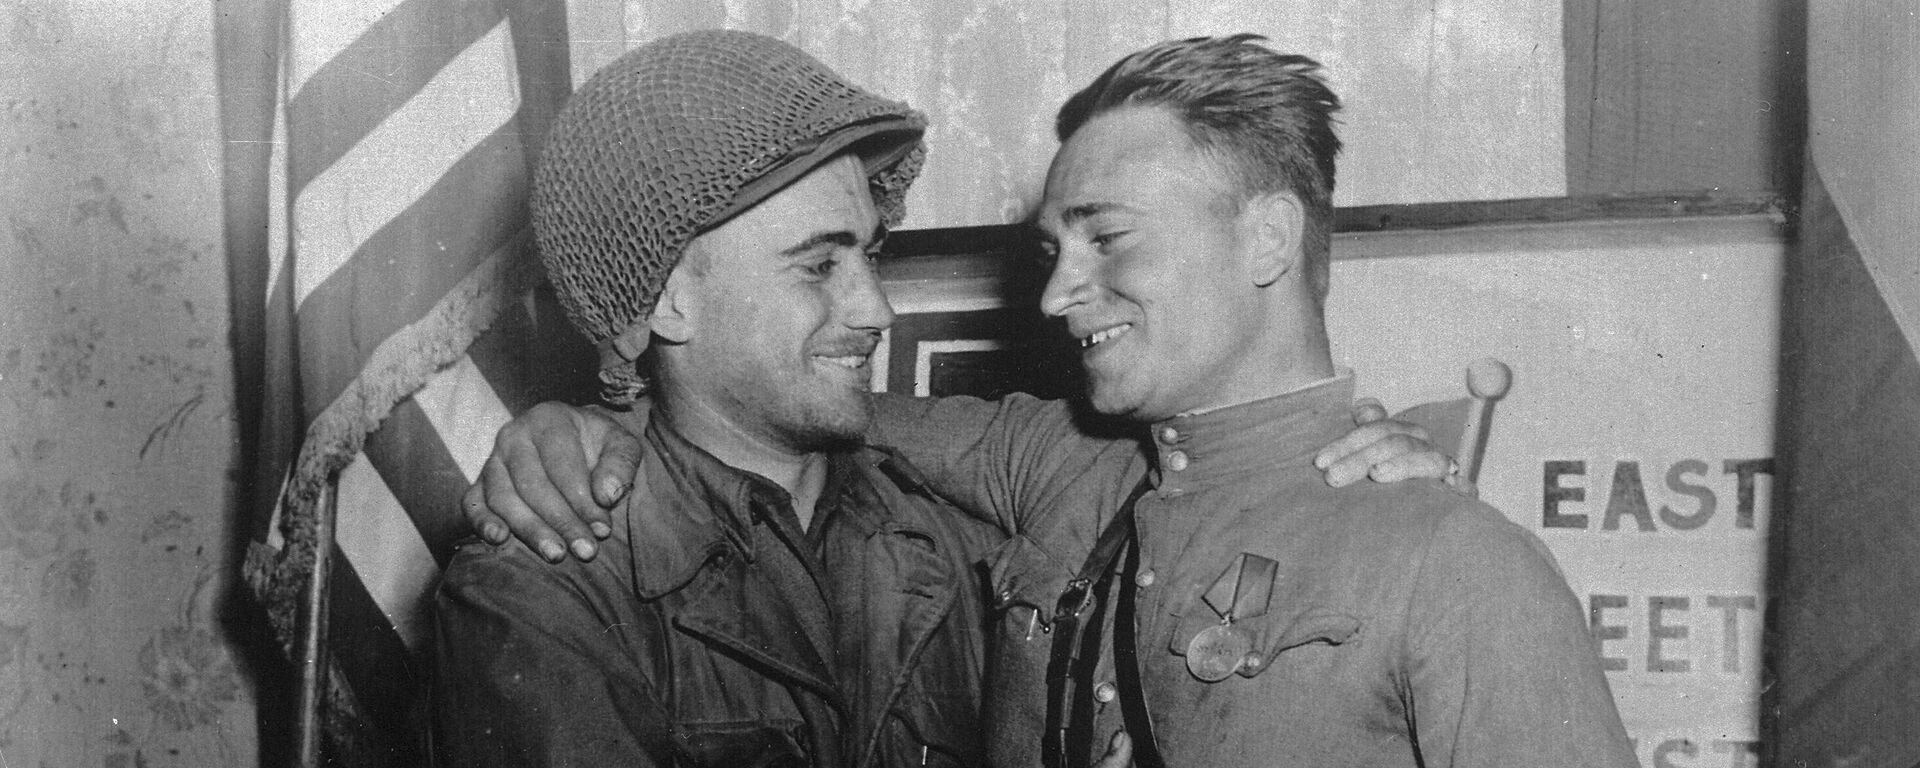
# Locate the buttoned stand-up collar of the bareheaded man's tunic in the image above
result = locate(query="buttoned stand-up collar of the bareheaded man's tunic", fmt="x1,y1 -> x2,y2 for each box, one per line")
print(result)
1148,369 -> 1354,497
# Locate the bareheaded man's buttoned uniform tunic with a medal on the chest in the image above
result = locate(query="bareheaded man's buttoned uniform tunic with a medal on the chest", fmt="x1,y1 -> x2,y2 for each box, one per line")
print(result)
881,376 -> 1634,766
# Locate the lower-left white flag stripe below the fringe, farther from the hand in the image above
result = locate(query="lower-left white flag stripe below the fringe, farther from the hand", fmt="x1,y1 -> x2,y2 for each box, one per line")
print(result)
334,453 -> 440,649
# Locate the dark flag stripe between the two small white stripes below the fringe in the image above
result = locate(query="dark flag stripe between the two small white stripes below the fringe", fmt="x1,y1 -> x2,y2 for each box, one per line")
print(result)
365,397 -> 467,568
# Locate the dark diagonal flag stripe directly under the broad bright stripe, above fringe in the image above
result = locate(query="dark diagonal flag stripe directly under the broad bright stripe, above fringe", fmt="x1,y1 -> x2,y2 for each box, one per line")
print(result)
288,121 -> 526,415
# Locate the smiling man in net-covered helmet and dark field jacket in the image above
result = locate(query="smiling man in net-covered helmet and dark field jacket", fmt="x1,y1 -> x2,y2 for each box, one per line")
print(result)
436,31 -> 998,766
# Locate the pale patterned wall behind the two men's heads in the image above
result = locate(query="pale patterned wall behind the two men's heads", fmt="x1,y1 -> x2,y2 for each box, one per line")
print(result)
568,0 -> 1567,227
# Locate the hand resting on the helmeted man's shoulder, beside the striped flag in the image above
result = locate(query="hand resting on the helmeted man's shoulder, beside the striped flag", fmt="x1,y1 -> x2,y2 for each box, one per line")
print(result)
461,403 -> 639,563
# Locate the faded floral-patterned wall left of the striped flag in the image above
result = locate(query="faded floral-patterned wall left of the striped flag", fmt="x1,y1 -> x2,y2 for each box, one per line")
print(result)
0,0 -> 255,768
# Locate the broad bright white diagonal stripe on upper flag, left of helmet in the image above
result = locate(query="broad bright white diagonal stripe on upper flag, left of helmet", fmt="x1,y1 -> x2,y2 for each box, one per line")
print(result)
294,21 -> 520,307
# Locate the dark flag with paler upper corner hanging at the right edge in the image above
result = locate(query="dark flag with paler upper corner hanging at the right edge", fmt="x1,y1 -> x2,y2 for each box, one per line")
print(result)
1763,0 -> 1920,768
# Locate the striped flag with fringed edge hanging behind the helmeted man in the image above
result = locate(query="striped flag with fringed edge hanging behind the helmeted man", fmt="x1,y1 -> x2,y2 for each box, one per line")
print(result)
223,0 -> 591,764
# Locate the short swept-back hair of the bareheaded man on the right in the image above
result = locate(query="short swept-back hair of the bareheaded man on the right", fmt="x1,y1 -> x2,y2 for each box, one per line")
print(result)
1054,35 -> 1340,301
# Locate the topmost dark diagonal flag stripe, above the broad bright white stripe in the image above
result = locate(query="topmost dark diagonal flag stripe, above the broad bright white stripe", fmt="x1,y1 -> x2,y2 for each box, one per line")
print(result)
286,0 -> 507,196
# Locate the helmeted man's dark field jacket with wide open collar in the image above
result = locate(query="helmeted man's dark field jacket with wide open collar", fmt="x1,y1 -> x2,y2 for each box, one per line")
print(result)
434,410 -> 1000,766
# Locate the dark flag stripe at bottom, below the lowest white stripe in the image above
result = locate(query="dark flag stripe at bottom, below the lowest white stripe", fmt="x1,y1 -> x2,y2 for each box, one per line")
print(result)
326,553 -> 428,766
